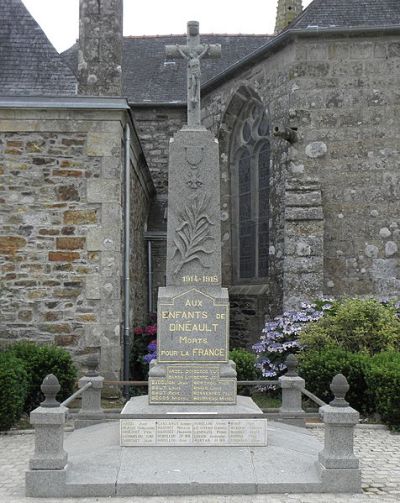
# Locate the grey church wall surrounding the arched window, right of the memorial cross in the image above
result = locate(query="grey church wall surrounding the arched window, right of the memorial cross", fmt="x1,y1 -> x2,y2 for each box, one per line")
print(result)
203,33 -> 400,340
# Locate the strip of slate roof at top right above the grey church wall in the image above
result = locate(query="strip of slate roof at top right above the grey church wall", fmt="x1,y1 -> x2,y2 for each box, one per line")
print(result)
289,0 -> 400,29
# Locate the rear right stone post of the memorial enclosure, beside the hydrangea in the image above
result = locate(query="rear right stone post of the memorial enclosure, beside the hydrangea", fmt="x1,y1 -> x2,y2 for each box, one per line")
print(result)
278,354 -> 305,426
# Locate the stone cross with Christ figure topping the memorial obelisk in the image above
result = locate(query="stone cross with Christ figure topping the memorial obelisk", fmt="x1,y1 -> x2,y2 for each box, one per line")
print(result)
165,21 -> 221,127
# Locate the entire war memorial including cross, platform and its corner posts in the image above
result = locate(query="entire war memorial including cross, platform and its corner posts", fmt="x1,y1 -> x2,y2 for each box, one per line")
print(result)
26,21 -> 361,497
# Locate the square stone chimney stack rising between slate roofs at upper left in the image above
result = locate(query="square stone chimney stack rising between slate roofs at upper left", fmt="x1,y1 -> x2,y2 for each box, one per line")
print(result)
78,0 -> 123,96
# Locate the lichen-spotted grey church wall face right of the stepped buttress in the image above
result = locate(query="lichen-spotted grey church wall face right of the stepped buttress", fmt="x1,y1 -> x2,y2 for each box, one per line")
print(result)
290,36 -> 400,297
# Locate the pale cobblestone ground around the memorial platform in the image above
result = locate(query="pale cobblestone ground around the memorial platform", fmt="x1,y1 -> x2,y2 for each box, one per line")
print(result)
0,428 -> 400,503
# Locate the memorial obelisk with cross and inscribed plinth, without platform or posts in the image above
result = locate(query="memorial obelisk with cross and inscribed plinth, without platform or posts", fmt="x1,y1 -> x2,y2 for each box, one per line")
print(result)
121,21 -> 266,446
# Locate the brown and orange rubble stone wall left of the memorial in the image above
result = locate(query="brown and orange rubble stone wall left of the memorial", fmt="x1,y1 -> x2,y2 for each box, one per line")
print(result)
0,107 -> 151,378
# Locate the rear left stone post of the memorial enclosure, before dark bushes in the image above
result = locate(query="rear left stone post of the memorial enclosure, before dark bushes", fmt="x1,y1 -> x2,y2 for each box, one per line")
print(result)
75,355 -> 104,428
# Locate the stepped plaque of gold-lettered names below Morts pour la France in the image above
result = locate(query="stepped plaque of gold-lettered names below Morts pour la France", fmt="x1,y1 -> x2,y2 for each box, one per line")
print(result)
149,364 -> 236,404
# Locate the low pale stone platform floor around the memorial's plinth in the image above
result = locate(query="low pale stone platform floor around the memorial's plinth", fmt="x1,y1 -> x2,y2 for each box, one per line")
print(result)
26,421 -> 360,498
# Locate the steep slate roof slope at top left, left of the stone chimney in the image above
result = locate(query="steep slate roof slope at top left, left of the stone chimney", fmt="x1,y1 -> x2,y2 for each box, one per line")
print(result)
0,0 -> 77,96
